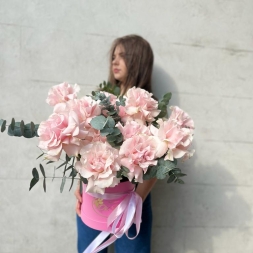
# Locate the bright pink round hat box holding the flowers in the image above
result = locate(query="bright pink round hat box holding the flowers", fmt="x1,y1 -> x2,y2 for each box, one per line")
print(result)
81,181 -> 135,231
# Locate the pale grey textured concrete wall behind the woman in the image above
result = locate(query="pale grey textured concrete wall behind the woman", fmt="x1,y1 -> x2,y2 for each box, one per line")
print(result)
0,0 -> 253,253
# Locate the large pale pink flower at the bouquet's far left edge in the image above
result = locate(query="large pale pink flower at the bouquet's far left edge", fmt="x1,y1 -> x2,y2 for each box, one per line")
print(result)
38,112 -> 80,161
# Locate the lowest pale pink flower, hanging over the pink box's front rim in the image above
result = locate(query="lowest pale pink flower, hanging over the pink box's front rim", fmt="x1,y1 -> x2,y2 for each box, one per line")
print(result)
75,142 -> 120,194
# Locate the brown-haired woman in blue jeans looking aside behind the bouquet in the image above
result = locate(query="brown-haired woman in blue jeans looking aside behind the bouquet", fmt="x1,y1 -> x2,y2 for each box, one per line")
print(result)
75,35 -> 156,253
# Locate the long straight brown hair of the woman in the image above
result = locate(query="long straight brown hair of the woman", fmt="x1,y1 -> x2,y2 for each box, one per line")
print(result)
109,35 -> 154,94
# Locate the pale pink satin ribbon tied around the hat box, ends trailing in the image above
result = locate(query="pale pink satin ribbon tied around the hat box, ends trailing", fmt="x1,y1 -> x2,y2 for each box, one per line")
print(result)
83,187 -> 142,253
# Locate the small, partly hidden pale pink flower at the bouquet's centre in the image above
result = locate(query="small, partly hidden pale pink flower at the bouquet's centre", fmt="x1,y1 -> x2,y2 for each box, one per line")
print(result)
116,121 -> 151,140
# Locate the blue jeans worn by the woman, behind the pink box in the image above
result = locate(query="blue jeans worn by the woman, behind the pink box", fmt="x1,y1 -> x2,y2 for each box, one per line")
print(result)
77,194 -> 152,253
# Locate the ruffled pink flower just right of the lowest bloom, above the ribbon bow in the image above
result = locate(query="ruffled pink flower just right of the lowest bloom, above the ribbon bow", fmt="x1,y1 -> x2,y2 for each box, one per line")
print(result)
119,135 -> 162,183
